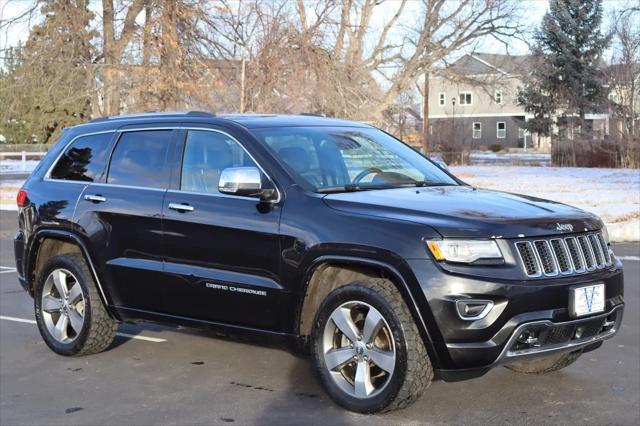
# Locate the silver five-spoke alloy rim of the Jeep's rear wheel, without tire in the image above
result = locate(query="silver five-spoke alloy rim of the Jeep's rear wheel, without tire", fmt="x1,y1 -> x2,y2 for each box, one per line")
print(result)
41,269 -> 85,344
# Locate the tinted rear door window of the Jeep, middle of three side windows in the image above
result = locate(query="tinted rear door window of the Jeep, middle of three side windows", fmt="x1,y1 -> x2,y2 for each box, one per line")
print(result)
107,130 -> 173,188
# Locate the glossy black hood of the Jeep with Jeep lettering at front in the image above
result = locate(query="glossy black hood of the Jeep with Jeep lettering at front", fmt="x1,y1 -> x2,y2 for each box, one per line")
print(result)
324,186 -> 602,238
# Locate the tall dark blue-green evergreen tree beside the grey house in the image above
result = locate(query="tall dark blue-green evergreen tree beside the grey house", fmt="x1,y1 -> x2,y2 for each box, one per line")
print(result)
519,0 -> 609,135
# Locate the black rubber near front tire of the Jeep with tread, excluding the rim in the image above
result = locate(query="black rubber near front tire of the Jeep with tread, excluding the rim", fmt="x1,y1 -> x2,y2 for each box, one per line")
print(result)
311,279 -> 433,413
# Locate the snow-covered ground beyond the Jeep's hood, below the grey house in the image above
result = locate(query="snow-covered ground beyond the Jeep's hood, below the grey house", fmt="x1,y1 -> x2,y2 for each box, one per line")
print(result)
450,166 -> 640,242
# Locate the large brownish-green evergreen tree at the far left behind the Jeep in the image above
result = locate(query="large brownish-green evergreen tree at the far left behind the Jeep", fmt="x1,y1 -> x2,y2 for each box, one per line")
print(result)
0,0 -> 96,143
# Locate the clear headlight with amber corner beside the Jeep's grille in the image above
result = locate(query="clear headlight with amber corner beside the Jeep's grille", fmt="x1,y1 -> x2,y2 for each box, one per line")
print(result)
427,240 -> 503,264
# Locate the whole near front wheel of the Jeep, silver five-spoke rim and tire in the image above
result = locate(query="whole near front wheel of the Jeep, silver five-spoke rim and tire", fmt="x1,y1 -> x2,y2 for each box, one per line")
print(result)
312,279 -> 433,413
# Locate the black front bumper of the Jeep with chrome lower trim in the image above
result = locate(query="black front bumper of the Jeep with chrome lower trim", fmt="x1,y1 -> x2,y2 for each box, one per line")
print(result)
409,260 -> 624,371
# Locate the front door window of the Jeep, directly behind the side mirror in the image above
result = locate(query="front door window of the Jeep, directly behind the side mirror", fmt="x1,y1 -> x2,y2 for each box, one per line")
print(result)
180,130 -> 257,193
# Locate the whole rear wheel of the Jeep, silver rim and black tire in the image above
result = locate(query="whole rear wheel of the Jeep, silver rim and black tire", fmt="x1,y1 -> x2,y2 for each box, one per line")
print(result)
34,253 -> 117,356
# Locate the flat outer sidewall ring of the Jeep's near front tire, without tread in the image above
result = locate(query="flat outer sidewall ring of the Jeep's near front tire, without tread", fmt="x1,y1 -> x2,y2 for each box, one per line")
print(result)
312,282 -> 407,413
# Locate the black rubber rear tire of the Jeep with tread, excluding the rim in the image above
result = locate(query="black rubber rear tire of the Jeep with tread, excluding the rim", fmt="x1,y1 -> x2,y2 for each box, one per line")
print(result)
34,253 -> 118,356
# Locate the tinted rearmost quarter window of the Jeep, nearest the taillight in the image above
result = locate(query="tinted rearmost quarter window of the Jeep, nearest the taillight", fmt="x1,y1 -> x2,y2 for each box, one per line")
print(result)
51,133 -> 113,182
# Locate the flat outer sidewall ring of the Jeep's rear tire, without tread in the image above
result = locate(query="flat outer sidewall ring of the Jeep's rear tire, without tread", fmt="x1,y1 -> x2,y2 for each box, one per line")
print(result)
33,255 -> 92,356
